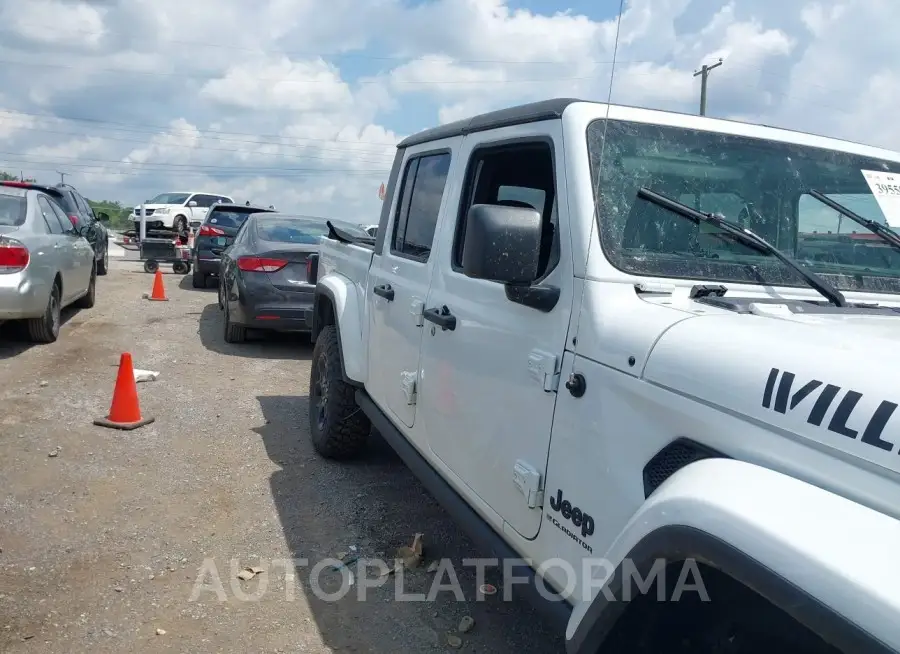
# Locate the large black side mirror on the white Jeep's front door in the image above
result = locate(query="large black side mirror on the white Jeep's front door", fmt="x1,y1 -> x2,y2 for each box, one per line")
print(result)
462,204 -> 542,285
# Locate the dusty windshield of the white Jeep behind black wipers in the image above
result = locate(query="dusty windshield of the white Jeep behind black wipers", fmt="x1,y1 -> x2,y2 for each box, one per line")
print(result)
587,120 -> 900,294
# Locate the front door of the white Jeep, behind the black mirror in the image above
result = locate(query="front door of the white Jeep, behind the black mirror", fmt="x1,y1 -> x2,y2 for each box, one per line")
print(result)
419,121 -> 573,538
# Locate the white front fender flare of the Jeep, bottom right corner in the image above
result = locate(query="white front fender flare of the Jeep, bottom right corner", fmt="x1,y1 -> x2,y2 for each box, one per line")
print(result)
566,459 -> 900,654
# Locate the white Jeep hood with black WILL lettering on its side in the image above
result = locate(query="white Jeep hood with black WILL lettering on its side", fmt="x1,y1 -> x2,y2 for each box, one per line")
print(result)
642,304 -> 900,472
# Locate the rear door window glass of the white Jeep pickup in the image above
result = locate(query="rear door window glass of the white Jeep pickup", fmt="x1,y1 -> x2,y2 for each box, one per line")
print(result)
391,153 -> 450,262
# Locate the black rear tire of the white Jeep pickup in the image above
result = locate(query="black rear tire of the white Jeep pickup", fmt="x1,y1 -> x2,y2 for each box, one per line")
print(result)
309,325 -> 372,459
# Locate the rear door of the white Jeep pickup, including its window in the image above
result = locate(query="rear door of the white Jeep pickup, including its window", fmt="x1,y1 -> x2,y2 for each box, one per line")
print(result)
366,142 -> 452,427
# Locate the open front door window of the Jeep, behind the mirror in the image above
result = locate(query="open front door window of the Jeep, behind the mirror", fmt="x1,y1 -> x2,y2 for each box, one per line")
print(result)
452,143 -> 560,279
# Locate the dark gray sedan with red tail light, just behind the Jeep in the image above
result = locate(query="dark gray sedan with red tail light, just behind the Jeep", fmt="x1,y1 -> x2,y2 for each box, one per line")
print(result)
219,212 -> 328,343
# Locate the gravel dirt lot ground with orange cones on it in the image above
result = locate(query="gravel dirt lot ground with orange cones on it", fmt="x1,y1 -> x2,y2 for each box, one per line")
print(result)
0,260 -> 563,654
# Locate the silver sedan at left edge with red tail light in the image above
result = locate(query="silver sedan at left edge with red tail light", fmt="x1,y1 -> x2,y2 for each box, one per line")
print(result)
0,182 -> 97,343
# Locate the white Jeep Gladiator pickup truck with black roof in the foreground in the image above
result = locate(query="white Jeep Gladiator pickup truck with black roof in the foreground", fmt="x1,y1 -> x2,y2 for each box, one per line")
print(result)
310,99 -> 900,654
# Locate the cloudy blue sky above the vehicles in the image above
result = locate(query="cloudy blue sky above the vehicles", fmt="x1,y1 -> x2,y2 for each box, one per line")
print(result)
0,0 -> 900,223
